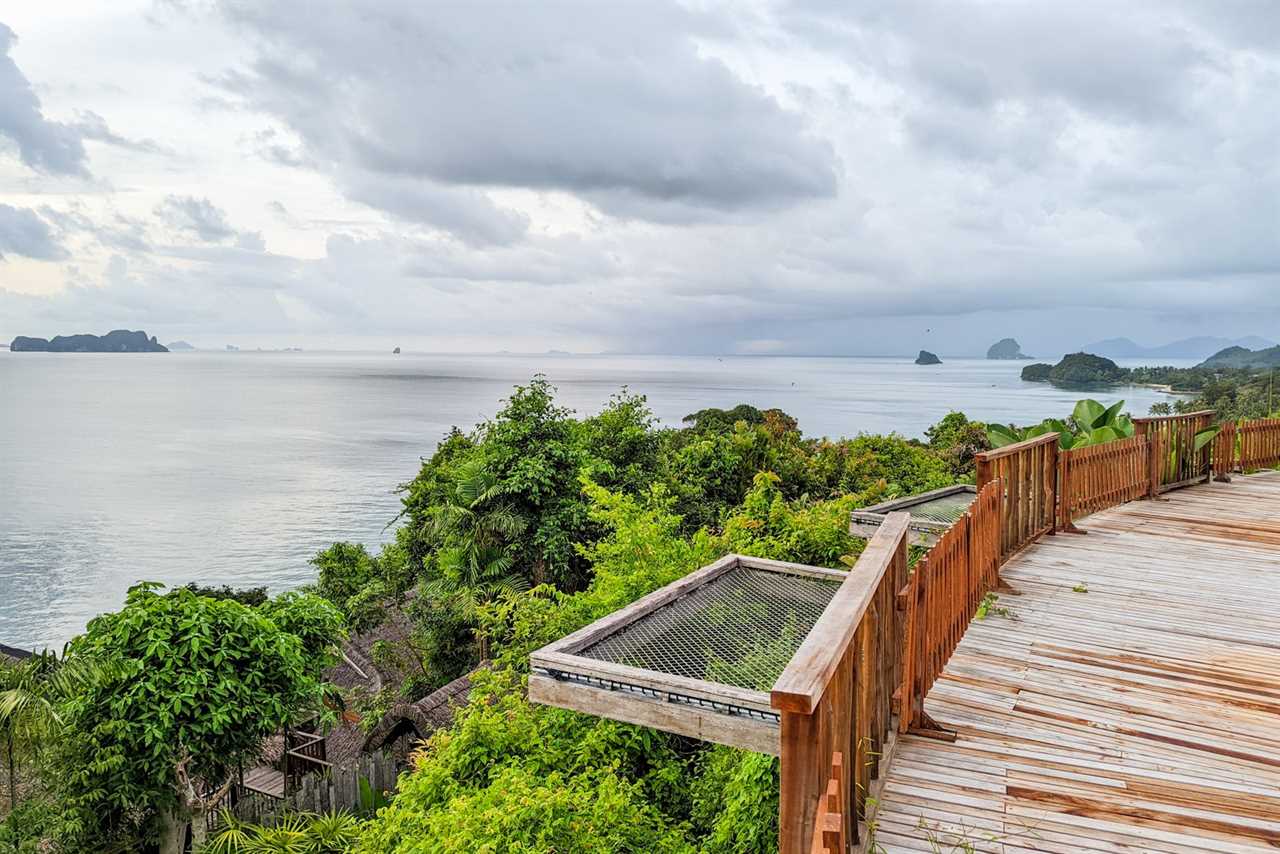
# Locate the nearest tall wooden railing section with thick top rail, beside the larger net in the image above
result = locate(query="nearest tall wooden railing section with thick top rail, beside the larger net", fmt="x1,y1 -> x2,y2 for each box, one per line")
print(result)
771,512 -> 910,854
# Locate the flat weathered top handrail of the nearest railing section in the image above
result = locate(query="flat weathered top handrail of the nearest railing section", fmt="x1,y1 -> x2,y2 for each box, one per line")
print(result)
769,511 -> 911,714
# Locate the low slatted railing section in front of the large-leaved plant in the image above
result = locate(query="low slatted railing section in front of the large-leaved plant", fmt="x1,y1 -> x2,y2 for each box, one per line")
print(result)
1057,435 -> 1151,530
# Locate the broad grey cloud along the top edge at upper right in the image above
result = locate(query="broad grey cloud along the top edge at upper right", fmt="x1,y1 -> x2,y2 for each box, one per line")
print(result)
780,0 -> 1213,122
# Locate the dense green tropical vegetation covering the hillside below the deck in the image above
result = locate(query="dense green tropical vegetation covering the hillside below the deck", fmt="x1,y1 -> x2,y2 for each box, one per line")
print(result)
0,378 -> 1259,854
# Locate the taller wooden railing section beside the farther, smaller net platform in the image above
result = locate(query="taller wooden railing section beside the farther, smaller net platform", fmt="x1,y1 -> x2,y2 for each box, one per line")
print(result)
975,433 -> 1057,560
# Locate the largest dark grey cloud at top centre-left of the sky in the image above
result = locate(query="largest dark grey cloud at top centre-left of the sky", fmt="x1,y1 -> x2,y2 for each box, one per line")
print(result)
215,0 -> 837,220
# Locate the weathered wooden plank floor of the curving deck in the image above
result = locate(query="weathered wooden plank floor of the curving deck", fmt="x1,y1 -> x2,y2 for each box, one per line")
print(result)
873,474 -> 1280,854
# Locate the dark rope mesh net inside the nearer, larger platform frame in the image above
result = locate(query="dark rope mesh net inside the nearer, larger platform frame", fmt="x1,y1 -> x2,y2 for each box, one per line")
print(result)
577,566 -> 840,691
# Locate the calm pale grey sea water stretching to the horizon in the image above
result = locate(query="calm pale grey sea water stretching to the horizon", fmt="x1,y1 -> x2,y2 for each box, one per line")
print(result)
0,351 -> 1182,648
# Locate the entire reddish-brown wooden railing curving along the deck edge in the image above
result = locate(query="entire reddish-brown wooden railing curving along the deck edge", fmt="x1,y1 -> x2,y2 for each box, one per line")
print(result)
793,412 -> 1280,854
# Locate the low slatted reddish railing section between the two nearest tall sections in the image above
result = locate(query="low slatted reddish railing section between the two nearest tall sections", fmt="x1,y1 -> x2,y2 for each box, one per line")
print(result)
899,480 -> 1005,732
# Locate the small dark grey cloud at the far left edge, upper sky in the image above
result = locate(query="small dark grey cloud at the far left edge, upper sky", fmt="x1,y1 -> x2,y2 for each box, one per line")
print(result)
0,23 -> 88,177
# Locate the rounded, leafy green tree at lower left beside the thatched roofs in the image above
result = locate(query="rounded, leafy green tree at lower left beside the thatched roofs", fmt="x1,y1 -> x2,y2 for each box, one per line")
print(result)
60,584 -> 342,854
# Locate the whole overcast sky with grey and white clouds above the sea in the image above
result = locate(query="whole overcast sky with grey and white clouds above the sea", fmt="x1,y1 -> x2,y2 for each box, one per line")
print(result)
0,0 -> 1280,355
